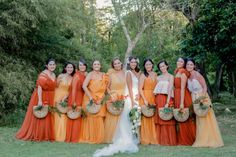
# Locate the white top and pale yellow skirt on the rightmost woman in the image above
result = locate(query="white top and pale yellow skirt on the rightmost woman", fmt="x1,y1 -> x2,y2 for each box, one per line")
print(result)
188,79 -> 224,148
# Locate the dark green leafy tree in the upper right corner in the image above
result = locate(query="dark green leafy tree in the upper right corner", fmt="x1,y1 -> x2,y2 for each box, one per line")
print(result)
179,0 -> 236,97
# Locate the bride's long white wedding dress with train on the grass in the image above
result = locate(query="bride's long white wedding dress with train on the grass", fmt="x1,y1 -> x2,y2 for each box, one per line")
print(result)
93,71 -> 139,157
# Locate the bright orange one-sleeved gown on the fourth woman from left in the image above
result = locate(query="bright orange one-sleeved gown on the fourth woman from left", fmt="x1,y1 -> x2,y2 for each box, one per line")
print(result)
81,74 -> 108,144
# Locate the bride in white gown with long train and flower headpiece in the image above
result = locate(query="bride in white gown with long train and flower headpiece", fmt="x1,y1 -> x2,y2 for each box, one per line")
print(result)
93,57 -> 140,157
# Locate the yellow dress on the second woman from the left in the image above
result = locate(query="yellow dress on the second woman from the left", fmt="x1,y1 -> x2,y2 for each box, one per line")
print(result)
54,77 -> 71,142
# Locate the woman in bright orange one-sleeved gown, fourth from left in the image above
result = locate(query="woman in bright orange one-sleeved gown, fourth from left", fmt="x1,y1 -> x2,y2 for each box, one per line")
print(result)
81,60 -> 108,144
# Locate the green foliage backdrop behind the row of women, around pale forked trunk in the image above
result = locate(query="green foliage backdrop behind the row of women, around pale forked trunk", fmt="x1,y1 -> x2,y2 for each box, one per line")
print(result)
0,0 -> 236,125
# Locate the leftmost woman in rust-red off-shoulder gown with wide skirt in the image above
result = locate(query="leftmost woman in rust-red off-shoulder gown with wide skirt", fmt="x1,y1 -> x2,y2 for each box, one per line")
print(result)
16,59 -> 56,141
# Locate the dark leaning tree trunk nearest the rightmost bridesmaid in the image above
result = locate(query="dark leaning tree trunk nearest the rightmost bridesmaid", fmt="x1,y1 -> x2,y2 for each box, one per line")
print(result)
213,64 -> 224,98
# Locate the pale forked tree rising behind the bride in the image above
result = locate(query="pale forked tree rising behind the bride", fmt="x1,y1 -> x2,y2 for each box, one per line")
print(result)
112,0 -> 159,65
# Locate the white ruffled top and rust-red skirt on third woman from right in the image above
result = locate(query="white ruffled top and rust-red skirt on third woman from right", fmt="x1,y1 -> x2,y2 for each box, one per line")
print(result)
155,80 -> 177,146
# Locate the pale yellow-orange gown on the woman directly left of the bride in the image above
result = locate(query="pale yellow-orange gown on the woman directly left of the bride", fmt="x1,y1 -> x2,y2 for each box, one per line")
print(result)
104,72 -> 126,143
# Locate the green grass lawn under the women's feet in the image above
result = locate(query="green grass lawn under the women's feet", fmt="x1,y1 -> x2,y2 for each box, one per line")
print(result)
0,93 -> 236,157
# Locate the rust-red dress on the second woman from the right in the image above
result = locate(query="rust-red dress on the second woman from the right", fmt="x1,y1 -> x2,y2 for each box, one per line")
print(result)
174,68 -> 196,146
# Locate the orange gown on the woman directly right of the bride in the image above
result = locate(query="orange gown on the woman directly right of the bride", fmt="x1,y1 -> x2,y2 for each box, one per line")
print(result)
139,77 -> 158,144
